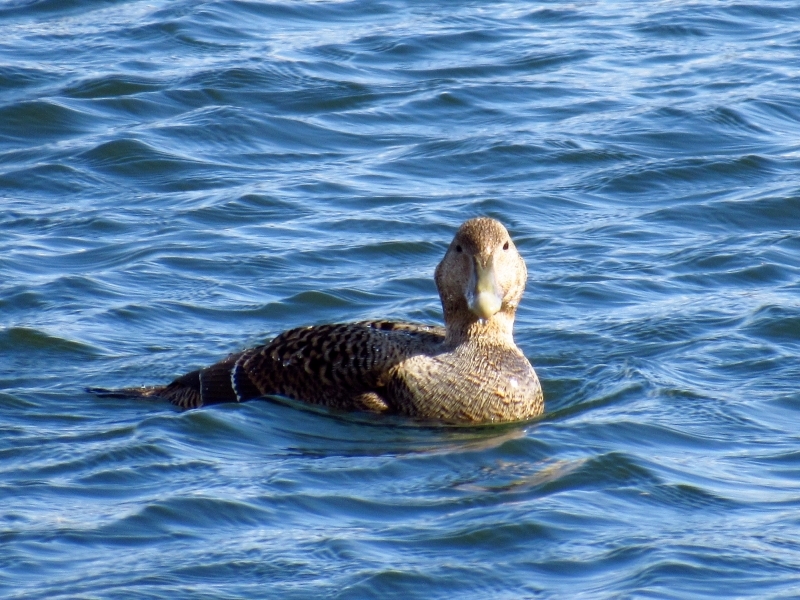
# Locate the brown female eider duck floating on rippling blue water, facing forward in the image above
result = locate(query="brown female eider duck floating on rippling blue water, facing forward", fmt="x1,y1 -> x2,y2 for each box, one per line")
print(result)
124,217 -> 544,424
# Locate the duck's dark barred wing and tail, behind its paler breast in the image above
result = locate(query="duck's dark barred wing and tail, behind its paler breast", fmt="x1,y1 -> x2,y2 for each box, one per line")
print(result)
147,321 -> 445,411
